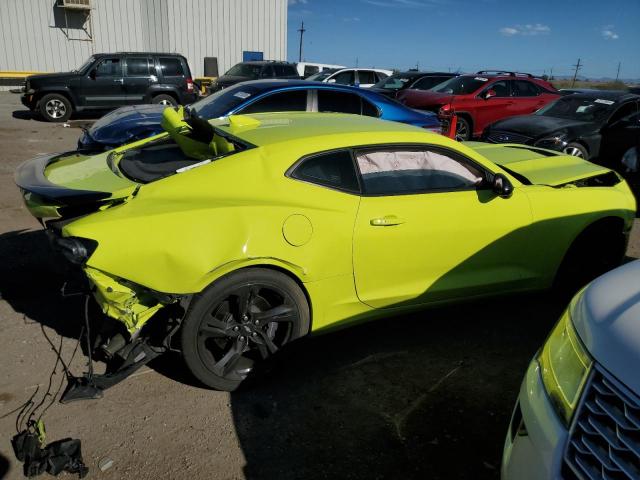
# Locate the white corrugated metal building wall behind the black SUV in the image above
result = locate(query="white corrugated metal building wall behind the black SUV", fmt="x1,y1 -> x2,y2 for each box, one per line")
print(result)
0,0 -> 287,76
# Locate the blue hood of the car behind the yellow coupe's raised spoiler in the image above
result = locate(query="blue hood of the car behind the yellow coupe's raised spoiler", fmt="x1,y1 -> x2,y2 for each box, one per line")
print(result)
89,105 -> 167,145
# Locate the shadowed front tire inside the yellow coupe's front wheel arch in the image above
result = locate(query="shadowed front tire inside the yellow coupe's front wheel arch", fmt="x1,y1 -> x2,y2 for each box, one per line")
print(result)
554,222 -> 625,295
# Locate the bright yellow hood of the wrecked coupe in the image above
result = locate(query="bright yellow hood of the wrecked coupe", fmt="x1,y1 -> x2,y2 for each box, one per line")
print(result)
465,142 -> 611,187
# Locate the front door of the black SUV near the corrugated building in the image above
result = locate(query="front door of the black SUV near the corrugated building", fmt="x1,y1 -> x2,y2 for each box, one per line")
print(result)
83,57 -> 127,107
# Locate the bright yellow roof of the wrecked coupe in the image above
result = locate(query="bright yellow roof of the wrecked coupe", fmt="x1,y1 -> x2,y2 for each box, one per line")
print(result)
211,112 -> 430,147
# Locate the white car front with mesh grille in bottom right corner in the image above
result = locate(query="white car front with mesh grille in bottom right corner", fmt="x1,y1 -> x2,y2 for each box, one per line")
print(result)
502,260 -> 640,480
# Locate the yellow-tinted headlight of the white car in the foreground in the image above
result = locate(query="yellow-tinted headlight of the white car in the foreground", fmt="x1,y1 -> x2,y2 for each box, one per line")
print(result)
538,309 -> 592,427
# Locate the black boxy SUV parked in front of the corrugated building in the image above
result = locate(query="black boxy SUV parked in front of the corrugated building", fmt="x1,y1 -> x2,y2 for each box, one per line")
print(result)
22,52 -> 197,122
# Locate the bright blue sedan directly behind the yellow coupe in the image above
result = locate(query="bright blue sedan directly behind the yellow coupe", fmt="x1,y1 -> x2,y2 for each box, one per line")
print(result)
78,80 -> 441,150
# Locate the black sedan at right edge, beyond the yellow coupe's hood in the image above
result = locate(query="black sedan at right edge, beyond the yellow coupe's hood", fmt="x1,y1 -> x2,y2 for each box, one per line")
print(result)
483,91 -> 640,170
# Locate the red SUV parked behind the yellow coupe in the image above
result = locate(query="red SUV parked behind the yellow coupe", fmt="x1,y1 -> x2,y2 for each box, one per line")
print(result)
398,70 -> 560,141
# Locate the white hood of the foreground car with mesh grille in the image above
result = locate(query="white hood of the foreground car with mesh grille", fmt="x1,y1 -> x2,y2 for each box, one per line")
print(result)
571,260 -> 640,395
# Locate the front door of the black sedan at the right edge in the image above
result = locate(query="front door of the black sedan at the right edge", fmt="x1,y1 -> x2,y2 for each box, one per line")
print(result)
600,100 -> 640,164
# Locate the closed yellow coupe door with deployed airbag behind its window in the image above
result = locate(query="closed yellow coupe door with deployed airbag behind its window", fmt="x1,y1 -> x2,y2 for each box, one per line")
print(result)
353,145 -> 533,308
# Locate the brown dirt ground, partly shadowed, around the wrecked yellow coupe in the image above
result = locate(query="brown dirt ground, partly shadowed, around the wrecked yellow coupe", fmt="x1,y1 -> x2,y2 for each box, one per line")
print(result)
0,93 -> 640,480
